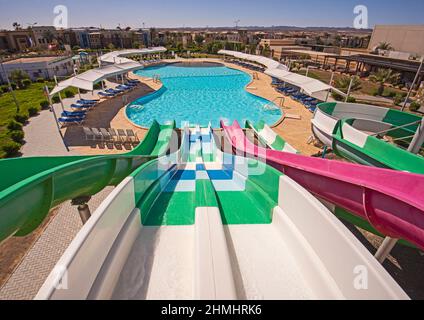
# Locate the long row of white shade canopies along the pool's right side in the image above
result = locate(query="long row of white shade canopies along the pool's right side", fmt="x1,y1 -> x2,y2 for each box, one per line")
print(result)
218,50 -> 334,96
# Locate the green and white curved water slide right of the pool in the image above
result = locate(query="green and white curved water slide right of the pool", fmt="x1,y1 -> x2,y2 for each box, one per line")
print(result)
311,102 -> 424,174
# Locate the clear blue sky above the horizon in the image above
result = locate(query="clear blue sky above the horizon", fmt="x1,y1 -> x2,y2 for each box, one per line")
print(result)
0,0 -> 424,29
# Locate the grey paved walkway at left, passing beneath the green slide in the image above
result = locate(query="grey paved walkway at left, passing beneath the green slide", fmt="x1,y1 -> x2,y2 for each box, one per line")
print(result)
0,93 -> 113,300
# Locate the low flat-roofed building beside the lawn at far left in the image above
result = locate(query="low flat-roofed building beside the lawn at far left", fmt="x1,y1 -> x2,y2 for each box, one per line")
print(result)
0,57 -> 74,83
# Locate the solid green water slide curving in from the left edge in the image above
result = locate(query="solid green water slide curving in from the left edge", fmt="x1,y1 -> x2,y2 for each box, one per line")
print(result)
0,121 -> 175,241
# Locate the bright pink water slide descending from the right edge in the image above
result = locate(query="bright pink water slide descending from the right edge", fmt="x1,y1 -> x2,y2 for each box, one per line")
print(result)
221,121 -> 424,249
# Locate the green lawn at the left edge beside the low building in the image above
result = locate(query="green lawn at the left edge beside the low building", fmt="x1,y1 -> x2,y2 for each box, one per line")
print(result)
0,82 -> 76,158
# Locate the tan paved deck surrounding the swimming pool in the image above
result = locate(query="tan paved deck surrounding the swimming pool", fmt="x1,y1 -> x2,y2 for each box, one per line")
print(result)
62,59 -> 320,155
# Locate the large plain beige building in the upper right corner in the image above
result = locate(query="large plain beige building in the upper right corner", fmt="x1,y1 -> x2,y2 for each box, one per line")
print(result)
368,25 -> 424,56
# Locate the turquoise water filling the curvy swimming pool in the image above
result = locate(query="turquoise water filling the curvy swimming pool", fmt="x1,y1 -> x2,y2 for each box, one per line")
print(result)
126,64 -> 281,128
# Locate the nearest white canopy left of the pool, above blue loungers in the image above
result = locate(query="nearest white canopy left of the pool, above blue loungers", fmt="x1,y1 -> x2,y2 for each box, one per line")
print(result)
50,60 -> 143,96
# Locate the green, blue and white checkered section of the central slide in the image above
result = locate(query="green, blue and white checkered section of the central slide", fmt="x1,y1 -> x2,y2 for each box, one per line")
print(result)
131,128 -> 282,227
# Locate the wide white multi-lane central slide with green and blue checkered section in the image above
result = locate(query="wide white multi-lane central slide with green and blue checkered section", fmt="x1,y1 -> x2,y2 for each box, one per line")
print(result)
36,127 -> 408,300
